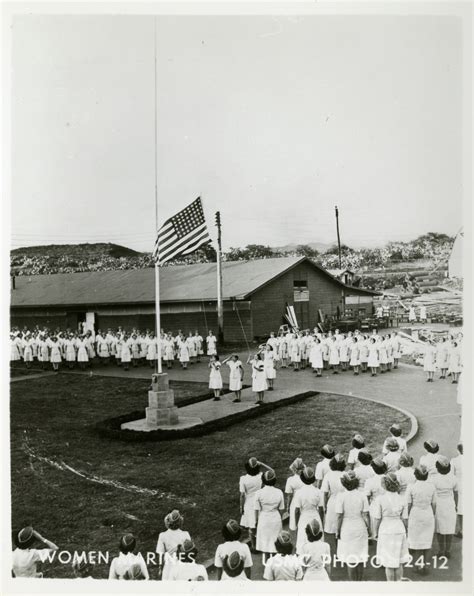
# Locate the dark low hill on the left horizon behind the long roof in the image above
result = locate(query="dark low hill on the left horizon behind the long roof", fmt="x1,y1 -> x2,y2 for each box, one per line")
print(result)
10,242 -> 143,259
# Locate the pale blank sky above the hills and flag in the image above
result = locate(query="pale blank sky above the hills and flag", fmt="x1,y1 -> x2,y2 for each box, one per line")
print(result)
12,16 -> 462,250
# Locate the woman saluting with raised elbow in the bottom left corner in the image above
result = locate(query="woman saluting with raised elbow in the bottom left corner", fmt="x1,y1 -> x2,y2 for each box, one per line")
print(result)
12,526 -> 59,577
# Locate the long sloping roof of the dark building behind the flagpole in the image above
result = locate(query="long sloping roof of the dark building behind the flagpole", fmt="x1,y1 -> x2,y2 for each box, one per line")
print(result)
11,257 -> 371,307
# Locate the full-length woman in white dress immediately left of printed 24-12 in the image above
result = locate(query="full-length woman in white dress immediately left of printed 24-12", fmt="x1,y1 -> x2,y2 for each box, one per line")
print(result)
374,472 -> 410,581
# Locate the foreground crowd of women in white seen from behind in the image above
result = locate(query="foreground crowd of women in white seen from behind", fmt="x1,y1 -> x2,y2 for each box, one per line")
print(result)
13,424 -> 463,582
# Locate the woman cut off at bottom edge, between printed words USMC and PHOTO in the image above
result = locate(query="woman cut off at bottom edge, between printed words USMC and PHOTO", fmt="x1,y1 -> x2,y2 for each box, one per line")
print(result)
301,519 -> 331,581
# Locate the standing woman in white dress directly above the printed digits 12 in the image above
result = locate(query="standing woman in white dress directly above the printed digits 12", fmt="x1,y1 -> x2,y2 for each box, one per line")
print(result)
431,455 -> 458,559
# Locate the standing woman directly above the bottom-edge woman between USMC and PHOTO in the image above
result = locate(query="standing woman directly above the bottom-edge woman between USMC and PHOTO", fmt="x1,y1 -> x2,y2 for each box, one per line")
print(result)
293,466 -> 324,555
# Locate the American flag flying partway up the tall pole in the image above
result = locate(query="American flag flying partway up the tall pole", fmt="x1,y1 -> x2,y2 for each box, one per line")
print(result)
153,197 -> 211,265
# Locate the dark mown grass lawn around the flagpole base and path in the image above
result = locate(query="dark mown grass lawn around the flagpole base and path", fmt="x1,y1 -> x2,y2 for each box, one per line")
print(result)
11,374 -> 410,577
